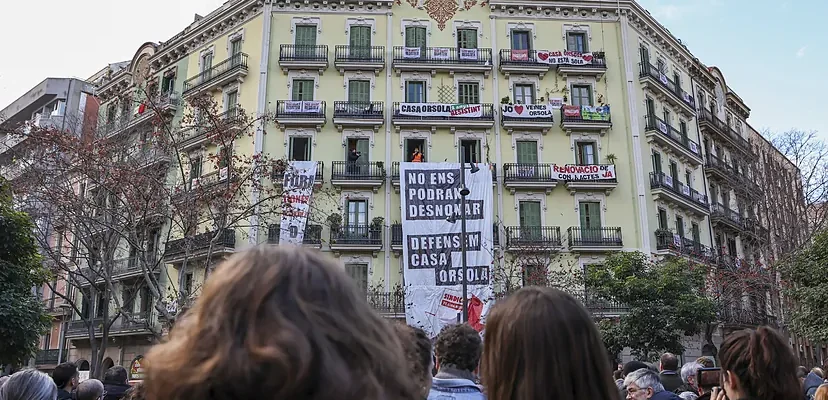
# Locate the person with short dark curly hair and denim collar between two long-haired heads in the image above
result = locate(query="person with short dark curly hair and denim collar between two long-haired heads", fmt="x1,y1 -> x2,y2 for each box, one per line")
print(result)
428,324 -> 486,400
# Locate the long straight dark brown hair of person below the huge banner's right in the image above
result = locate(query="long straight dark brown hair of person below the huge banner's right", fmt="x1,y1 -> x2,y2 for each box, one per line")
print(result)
480,286 -> 618,400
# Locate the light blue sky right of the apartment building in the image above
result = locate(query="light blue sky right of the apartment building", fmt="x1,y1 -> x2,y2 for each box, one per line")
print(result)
637,0 -> 828,139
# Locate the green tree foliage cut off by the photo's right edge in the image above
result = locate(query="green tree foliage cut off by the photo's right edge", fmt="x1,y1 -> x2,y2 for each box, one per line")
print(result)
780,230 -> 828,342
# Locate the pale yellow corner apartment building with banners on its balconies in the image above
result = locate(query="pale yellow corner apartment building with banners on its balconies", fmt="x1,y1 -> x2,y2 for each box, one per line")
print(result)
8,0 -> 796,365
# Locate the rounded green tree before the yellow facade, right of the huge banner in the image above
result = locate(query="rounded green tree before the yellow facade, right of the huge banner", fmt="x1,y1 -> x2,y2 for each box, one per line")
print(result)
586,252 -> 716,360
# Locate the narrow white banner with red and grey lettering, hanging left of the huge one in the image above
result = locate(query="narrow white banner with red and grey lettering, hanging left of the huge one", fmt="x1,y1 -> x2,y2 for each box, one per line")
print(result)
279,161 -> 316,245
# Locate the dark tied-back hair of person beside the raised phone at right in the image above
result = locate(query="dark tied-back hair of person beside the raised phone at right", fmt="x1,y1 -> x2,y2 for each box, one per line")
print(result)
719,326 -> 802,400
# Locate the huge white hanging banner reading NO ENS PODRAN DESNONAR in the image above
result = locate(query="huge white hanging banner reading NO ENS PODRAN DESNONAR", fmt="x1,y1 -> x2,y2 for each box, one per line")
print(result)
400,162 -> 494,337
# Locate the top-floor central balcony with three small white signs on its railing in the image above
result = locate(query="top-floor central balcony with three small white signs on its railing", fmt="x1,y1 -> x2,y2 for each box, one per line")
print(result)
392,46 -> 492,76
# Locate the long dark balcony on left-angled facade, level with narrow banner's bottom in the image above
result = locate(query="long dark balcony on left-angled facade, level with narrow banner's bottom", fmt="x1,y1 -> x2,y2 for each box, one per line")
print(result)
164,228 -> 236,264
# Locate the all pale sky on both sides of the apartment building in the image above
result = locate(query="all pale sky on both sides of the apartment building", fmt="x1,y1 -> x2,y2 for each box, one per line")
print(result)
0,0 -> 828,139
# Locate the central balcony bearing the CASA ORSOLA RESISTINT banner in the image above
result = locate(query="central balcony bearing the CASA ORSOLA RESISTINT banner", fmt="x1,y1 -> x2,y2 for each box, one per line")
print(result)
391,102 -> 494,131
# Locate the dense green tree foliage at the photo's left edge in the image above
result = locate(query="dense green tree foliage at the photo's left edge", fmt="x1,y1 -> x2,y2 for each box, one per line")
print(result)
0,178 -> 50,365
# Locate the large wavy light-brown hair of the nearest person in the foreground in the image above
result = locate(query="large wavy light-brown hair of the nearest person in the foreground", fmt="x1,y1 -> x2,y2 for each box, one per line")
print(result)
144,246 -> 419,400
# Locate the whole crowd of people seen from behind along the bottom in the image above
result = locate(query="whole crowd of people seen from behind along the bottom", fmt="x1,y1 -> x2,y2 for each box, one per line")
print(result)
0,247 -> 828,400
